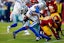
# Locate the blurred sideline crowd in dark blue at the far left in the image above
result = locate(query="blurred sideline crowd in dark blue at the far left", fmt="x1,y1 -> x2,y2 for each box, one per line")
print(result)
0,0 -> 14,22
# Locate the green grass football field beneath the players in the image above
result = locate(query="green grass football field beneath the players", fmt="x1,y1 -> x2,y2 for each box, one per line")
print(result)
0,22 -> 64,43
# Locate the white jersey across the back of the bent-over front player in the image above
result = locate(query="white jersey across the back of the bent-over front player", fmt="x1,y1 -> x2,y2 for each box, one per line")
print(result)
26,3 -> 45,17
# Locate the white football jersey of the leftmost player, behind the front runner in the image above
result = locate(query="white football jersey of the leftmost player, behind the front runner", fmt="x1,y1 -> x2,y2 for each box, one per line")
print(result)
12,1 -> 28,14
